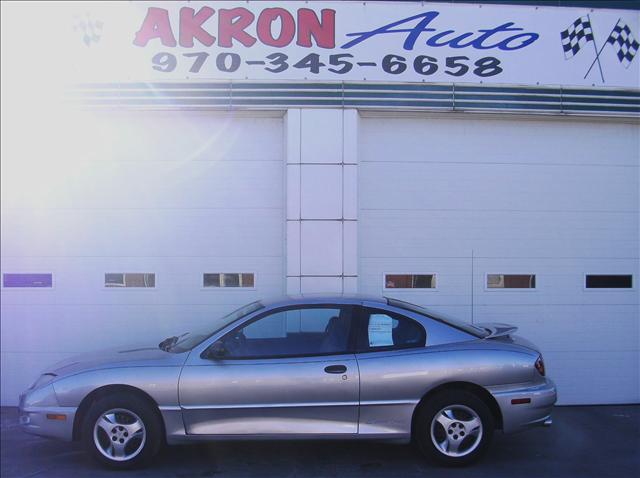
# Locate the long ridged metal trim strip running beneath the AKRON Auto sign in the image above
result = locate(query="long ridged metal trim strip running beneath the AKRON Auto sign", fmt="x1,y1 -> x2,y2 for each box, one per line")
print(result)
66,81 -> 640,117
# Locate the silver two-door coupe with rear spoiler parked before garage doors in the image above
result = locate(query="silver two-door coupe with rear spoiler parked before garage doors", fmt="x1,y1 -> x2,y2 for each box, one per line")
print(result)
20,296 -> 556,468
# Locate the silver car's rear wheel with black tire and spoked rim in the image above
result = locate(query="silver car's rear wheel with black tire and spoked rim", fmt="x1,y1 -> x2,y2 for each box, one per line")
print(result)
414,390 -> 495,466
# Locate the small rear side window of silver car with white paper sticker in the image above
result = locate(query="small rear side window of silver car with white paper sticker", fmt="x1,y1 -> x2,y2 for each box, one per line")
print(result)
359,308 -> 426,351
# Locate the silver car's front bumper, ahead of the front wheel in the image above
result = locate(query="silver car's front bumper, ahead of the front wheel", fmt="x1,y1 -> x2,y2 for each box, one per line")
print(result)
19,386 -> 77,441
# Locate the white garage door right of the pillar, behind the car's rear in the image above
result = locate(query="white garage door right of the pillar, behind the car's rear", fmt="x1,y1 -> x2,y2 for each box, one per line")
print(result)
359,115 -> 640,404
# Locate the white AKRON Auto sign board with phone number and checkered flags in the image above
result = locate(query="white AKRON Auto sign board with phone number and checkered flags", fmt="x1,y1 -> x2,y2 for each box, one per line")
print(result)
17,1 -> 640,88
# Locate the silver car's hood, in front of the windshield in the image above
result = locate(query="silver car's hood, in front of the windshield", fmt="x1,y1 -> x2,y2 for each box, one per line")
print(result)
43,344 -> 188,377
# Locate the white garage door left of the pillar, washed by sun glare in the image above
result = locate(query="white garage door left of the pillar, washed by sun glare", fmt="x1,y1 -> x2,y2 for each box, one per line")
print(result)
2,111 -> 284,405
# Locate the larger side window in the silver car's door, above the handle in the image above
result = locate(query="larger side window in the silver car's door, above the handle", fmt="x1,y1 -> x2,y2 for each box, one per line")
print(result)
222,306 -> 352,358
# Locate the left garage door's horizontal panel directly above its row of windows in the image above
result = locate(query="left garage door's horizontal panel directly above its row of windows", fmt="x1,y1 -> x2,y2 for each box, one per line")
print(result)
2,208 -> 283,257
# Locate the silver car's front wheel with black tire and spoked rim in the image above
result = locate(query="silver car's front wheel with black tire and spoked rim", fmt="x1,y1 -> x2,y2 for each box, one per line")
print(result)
81,393 -> 163,469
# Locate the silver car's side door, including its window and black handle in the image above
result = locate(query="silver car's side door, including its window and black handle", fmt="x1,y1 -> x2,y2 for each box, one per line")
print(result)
179,305 -> 359,435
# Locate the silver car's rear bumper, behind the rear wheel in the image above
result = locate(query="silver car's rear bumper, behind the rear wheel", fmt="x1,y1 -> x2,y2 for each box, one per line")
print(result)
489,379 -> 558,433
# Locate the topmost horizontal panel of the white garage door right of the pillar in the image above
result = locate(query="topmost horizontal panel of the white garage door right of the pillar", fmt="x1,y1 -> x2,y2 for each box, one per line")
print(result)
360,115 -> 640,167
